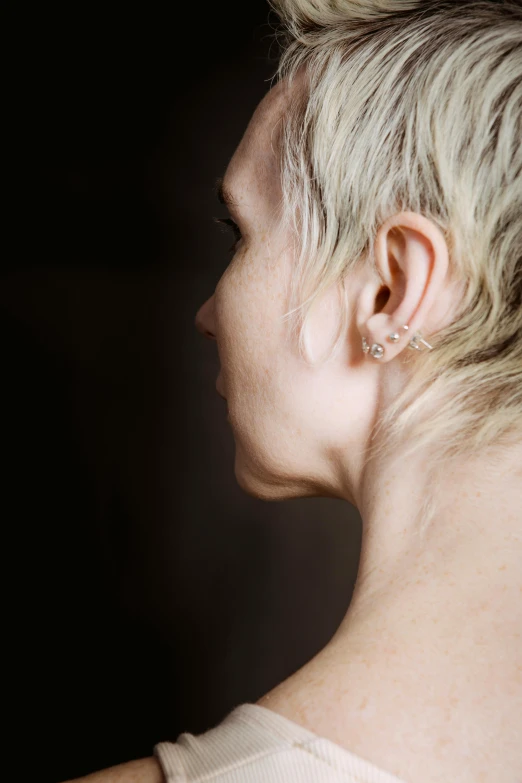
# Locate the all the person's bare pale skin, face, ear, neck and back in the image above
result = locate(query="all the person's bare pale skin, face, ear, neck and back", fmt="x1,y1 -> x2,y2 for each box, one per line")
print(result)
67,85 -> 522,783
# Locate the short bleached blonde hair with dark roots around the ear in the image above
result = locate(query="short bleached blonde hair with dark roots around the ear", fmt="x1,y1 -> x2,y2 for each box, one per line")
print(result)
271,0 -> 522,500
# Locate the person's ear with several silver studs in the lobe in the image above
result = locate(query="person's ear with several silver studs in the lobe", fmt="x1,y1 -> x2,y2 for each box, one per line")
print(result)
357,212 -> 449,362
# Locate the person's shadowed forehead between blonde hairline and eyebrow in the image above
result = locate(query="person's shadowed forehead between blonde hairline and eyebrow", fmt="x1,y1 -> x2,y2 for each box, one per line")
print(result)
224,82 -> 288,207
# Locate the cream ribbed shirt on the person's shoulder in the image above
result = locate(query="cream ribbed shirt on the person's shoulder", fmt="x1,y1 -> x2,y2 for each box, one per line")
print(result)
154,704 -> 404,783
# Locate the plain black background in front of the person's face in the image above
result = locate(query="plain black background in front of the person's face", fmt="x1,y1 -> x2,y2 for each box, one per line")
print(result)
4,0 -> 360,783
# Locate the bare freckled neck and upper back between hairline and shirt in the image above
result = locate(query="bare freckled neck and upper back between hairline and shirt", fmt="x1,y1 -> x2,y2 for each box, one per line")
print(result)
260,440 -> 522,783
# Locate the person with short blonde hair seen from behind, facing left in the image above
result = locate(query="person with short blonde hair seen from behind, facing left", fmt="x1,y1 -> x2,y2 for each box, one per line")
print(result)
67,0 -> 522,783
